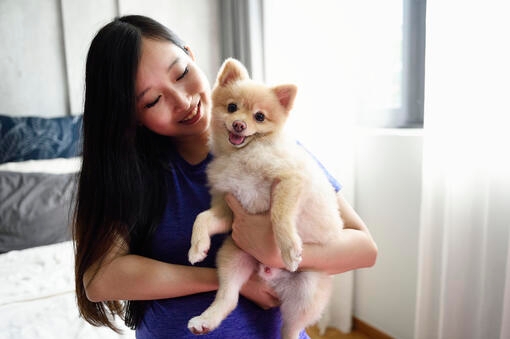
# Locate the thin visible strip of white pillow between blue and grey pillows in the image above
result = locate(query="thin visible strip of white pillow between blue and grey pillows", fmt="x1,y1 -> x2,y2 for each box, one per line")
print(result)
0,157 -> 81,174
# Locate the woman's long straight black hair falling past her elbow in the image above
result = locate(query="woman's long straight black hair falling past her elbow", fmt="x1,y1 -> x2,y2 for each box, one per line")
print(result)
73,15 -> 187,331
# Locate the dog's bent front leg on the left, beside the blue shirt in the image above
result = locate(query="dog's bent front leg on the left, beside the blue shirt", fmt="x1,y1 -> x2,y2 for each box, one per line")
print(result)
188,196 -> 232,264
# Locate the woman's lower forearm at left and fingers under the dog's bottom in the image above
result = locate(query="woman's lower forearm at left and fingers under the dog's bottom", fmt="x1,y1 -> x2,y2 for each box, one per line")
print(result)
83,238 -> 279,308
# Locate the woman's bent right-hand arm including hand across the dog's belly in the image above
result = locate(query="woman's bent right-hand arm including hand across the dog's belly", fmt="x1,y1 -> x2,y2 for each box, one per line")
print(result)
226,193 -> 377,274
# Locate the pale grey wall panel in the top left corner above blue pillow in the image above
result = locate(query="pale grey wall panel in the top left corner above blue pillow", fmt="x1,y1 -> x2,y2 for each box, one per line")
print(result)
0,0 -> 67,116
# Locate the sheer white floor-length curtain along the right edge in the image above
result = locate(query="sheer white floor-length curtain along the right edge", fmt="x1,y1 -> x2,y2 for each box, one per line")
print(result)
415,0 -> 510,339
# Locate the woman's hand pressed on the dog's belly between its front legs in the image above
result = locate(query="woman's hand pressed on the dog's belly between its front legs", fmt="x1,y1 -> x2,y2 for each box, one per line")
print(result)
225,193 -> 284,268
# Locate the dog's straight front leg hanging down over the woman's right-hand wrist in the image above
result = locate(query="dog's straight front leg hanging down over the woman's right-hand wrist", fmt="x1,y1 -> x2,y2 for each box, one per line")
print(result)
271,173 -> 303,272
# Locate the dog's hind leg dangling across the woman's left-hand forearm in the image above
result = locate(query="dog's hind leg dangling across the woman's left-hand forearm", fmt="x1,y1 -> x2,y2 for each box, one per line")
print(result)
188,237 -> 257,334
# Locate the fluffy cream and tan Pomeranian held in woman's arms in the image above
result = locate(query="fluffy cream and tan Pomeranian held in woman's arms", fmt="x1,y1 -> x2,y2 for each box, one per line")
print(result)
188,59 -> 343,339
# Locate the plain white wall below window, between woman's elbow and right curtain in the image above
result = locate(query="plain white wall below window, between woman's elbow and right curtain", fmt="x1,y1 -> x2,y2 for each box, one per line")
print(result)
354,130 -> 423,339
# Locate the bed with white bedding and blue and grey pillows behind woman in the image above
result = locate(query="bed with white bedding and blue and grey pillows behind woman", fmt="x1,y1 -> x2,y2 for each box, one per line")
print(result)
0,115 -> 134,339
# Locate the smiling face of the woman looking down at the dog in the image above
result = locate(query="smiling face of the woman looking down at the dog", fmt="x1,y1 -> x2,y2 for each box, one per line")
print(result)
135,38 -> 210,138
